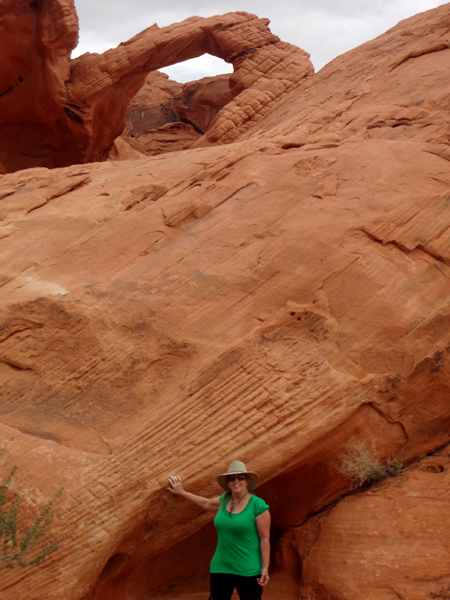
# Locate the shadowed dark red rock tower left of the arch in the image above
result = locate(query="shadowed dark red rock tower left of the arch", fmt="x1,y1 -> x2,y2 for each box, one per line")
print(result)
0,0 -> 80,173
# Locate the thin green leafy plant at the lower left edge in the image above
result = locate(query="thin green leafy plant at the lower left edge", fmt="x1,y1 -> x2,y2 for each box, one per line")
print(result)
0,438 -> 63,571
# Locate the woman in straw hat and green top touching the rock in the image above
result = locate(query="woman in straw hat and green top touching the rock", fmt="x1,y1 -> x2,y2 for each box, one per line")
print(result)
167,460 -> 270,600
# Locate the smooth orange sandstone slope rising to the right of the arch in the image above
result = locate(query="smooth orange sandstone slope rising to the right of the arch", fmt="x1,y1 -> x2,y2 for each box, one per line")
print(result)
243,5 -> 450,158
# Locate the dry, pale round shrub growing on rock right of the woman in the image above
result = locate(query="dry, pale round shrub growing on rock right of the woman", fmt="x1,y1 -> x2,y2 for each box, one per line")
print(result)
336,438 -> 403,488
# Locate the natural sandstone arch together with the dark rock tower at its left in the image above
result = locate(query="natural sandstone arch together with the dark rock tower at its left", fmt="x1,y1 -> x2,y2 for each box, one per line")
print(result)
0,0 -> 313,173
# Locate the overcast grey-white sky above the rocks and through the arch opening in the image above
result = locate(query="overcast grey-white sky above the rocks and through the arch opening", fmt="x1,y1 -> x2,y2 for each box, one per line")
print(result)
72,0 -> 446,82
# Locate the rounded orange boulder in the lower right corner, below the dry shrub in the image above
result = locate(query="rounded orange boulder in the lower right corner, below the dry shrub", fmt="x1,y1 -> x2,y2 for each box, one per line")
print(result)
276,451 -> 450,600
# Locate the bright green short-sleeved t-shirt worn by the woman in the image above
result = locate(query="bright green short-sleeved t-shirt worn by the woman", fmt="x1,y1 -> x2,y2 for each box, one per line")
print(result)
210,494 -> 269,577
